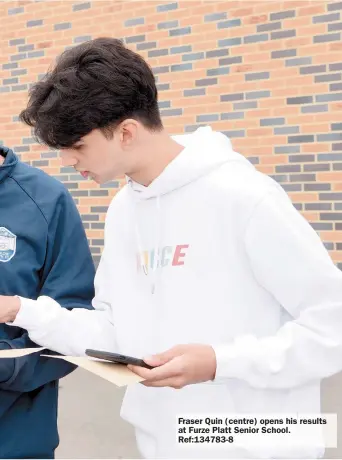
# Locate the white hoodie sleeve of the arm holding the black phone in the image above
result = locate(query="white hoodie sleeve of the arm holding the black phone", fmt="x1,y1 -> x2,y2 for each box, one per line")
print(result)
214,190 -> 342,389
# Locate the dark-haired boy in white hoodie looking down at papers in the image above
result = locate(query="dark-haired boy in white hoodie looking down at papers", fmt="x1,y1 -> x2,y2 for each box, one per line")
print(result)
0,38 -> 342,458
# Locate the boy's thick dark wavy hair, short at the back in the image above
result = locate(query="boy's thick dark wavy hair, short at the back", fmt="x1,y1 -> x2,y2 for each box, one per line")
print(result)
20,38 -> 163,149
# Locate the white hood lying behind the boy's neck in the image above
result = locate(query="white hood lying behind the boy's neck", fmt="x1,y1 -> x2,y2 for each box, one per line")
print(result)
128,126 -> 251,200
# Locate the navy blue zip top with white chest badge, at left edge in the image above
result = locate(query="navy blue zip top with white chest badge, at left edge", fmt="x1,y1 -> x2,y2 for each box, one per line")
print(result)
0,147 -> 94,458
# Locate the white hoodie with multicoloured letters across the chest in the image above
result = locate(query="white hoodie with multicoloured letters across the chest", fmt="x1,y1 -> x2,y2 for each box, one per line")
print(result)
13,127 -> 342,458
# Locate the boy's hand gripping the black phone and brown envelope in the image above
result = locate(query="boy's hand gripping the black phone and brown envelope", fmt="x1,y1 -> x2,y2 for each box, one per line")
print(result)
128,344 -> 216,389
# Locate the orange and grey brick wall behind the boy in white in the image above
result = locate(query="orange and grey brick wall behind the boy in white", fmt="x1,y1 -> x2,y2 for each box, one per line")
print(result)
0,0 -> 342,267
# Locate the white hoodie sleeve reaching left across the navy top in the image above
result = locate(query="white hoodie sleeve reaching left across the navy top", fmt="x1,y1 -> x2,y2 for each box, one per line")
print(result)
11,243 -> 117,356
